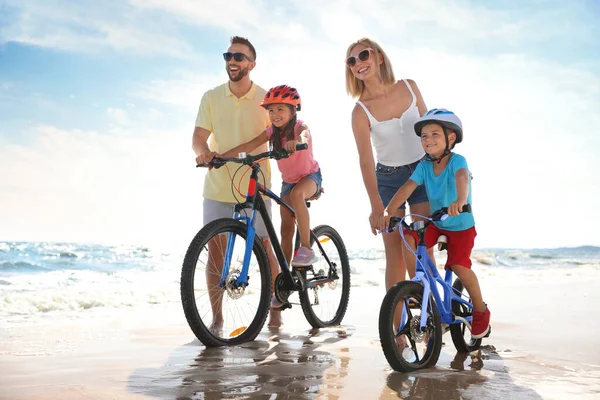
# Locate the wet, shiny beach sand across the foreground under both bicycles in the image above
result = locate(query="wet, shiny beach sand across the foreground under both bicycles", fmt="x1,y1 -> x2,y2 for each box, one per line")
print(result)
0,267 -> 600,400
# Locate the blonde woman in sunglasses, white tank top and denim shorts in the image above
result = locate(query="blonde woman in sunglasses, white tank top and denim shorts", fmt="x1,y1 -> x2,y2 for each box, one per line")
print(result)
346,38 -> 432,290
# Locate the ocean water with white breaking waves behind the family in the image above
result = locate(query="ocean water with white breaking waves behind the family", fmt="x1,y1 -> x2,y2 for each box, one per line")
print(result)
0,242 -> 600,327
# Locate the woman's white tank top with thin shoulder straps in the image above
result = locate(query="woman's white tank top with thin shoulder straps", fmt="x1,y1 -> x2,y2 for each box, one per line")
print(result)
357,79 -> 425,167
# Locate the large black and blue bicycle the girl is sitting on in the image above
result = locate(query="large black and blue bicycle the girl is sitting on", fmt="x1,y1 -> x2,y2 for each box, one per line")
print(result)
181,144 -> 350,346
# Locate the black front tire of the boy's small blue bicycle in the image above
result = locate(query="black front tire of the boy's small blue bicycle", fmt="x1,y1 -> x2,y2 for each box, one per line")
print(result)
379,281 -> 444,372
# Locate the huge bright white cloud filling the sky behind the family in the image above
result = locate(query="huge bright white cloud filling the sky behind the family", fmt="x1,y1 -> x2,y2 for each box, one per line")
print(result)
0,0 -> 600,247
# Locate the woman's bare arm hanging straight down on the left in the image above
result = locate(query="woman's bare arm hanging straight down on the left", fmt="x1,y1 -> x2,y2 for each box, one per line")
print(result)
352,104 -> 383,235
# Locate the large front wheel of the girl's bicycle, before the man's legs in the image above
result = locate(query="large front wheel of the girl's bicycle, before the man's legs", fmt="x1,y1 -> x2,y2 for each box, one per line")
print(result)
180,218 -> 271,347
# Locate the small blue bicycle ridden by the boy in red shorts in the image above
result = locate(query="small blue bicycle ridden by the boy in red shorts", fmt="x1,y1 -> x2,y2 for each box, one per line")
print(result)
379,205 -> 491,372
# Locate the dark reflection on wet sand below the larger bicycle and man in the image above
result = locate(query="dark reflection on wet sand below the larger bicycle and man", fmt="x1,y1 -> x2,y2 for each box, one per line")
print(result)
128,328 -> 349,400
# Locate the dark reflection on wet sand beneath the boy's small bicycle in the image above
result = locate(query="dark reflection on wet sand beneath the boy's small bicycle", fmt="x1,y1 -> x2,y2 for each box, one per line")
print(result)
380,345 -> 542,400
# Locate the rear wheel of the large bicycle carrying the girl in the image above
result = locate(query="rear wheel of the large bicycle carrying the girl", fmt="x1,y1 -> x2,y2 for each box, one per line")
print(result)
294,225 -> 350,328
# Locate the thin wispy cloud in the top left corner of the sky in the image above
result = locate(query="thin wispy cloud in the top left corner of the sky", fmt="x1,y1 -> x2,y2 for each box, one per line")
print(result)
0,0 -> 191,57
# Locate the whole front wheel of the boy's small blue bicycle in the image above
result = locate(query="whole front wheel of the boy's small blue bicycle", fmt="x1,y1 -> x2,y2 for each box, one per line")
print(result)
379,281 -> 444,372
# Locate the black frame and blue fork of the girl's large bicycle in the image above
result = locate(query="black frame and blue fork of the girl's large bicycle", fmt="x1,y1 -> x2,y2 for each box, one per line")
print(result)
219,164 -> 337,290
